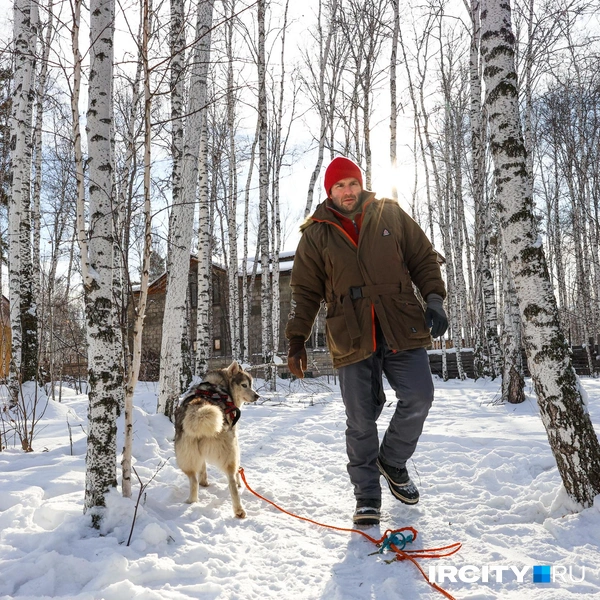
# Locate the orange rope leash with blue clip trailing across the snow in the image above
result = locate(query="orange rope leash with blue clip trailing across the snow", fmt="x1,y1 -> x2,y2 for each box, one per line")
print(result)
239,467 -> 462,600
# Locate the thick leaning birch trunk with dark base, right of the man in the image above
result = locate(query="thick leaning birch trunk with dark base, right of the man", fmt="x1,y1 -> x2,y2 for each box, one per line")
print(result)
481,0 -> 600,507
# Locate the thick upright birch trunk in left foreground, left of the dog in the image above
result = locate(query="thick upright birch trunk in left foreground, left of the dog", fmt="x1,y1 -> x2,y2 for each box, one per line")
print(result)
84,0 -> 123,527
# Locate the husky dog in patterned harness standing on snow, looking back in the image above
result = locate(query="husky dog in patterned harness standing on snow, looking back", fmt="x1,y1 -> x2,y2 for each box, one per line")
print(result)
175,361 -> 259,519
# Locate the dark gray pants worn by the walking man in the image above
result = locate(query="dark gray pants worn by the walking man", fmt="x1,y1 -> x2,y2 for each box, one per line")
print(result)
339,336 -> 433,499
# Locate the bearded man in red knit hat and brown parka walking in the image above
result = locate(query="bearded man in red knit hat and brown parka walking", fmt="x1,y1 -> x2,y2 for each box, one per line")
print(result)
286,157 -> 448,526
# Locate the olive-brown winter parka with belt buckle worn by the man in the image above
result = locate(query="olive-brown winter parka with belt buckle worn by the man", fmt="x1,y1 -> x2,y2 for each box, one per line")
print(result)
285,190 -> 446,368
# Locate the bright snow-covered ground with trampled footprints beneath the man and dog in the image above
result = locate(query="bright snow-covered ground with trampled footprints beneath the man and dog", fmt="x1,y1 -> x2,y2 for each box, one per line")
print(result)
0,372 -> 600,600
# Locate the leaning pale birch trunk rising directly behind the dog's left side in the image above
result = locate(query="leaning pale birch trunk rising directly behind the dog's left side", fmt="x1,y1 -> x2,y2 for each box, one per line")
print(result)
157,0 -> 214,417
